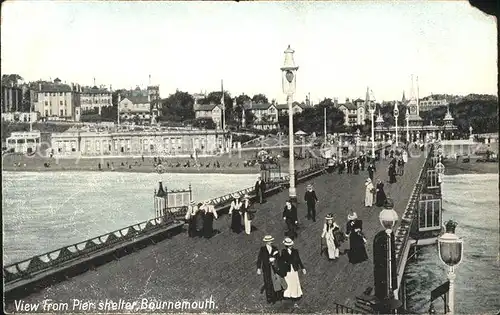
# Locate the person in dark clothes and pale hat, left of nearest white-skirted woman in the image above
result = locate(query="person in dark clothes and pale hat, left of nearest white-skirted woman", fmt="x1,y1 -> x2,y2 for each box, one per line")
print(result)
257,235 -> 286,303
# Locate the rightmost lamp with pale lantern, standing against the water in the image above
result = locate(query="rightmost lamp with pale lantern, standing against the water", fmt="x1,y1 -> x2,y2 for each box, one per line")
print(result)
438,220 -> 464,314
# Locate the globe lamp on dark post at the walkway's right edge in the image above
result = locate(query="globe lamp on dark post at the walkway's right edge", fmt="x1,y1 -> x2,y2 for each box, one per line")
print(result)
378,198 -> 402,312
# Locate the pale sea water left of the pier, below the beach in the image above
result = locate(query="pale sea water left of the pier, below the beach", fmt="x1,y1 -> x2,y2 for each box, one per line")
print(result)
2,172 -> 256,265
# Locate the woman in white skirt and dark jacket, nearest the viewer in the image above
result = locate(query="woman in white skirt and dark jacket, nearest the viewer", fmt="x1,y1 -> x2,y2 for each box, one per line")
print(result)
281,237 -> 306,306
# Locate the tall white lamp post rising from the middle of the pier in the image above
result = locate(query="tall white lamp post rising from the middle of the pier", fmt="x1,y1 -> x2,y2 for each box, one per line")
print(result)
281,45 -> 299,200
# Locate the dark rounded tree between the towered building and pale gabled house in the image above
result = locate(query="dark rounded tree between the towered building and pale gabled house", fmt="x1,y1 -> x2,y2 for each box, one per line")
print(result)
161,90 -> 195,122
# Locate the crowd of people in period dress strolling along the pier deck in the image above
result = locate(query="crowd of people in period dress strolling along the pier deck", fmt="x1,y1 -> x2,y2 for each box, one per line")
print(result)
182,146 -> 408,305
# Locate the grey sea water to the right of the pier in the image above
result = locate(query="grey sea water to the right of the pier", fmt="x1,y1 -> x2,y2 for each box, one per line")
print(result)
405,174 -> 500,314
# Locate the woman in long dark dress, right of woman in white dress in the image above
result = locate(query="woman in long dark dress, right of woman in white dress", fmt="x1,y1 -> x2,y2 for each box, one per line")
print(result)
346,212 -> 368,264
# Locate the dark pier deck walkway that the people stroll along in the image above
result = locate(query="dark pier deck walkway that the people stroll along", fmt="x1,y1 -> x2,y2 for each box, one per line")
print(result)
7,154 -> 425,313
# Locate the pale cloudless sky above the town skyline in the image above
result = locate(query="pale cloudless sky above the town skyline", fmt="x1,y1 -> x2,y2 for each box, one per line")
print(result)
1,0 -> 497,102
